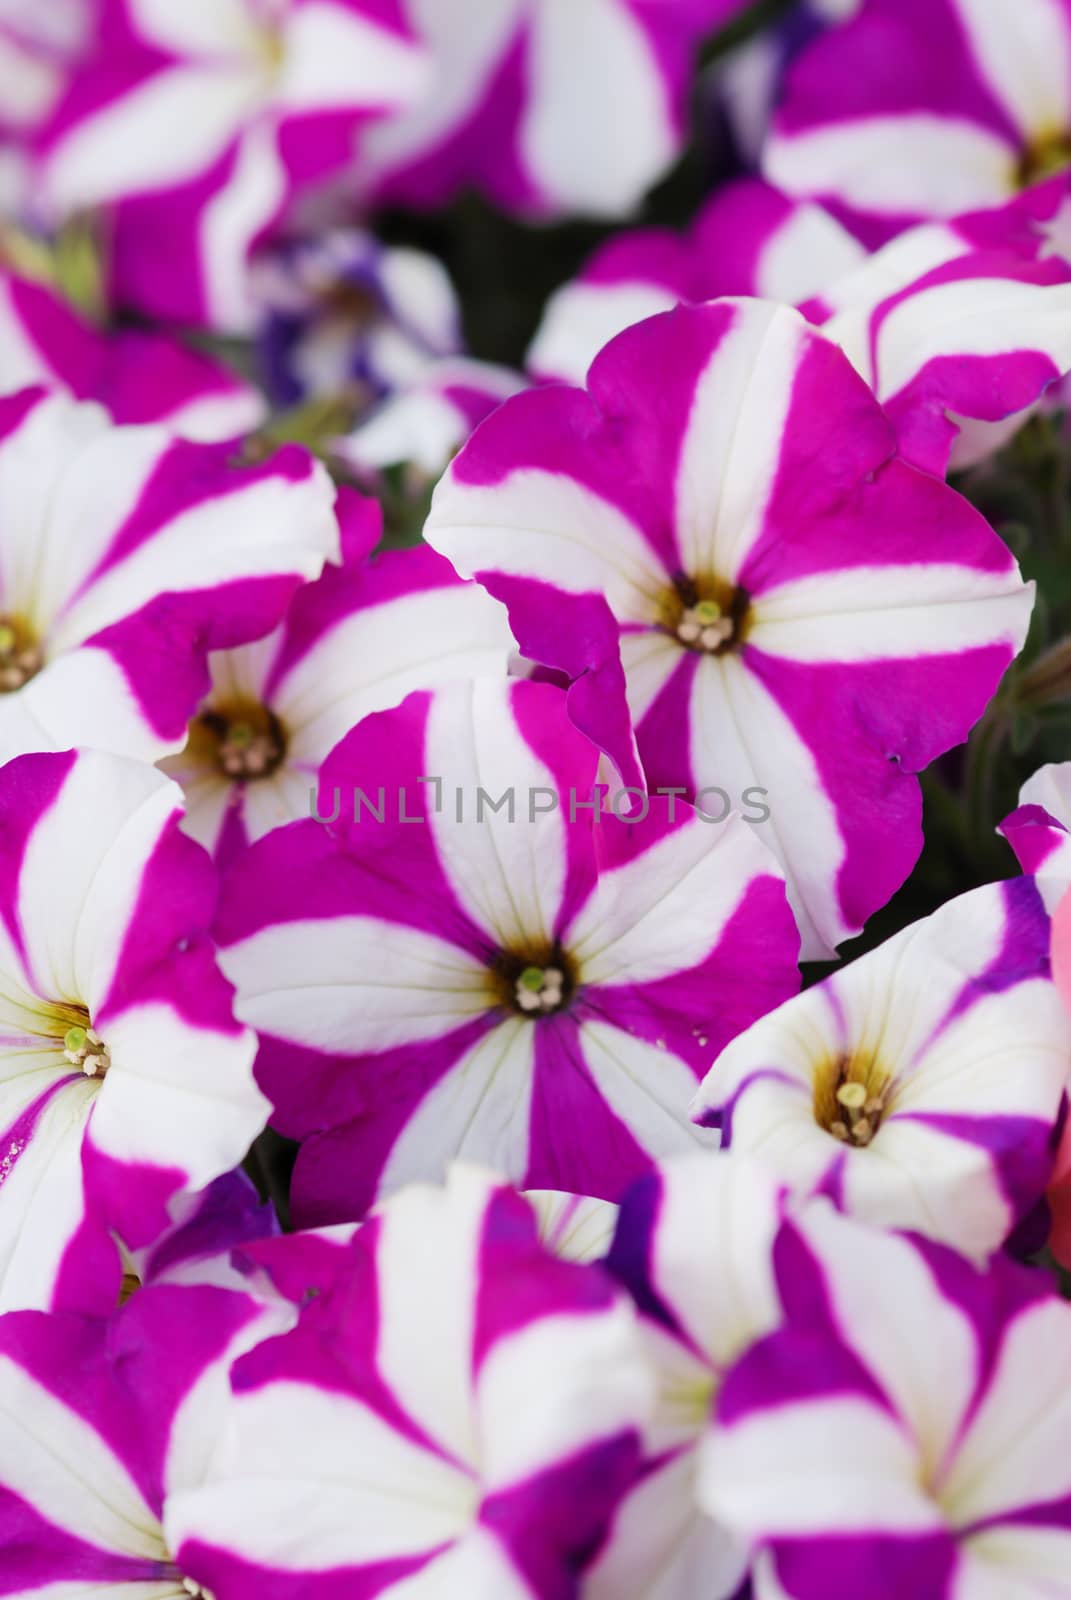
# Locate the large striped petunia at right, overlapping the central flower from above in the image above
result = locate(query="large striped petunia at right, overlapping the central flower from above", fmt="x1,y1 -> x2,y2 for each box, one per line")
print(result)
426,301 -> 1031,957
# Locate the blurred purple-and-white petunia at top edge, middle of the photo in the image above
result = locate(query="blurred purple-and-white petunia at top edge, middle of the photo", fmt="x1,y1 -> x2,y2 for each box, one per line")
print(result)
355,0 -> 741,218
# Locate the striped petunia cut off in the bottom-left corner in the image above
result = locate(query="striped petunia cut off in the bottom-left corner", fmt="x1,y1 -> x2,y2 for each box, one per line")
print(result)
0,1286 -> 295,1600
